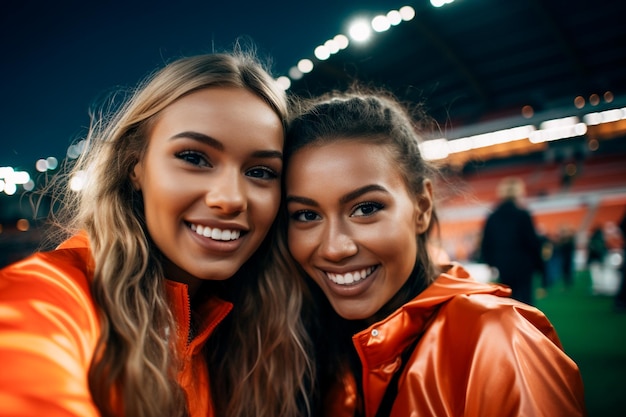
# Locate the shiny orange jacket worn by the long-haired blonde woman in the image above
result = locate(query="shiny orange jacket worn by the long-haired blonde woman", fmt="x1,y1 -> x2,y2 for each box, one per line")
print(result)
0,235 -> 232,417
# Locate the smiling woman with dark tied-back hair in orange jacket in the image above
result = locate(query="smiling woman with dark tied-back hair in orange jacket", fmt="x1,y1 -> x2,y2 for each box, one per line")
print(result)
282,86 -> 585,417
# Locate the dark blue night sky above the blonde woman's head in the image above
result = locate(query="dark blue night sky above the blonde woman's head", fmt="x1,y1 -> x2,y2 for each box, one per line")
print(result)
0,0 -> 404,171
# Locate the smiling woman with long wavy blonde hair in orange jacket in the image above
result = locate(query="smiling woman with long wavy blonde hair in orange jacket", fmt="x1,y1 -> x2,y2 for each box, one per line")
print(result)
0,52 -> 311,417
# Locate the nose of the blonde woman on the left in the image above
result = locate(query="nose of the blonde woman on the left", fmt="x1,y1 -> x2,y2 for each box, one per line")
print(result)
204,169 -> 248,214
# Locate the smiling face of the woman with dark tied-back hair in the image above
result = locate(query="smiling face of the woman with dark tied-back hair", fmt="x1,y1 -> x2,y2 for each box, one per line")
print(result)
286,139 -> 429,320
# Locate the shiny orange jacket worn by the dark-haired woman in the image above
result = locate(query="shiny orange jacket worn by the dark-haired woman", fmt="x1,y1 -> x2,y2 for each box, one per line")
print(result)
324,265 -> 586,417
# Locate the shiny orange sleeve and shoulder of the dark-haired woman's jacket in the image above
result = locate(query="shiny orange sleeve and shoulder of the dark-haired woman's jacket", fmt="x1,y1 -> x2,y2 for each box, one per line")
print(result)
392,295 -> 586,417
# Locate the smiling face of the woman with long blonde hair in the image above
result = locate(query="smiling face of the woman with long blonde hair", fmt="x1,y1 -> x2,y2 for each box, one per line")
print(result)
131,87 -> 283,285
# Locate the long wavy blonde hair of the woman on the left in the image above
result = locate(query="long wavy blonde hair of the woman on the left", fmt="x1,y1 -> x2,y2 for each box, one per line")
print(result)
51,50 -> 312,417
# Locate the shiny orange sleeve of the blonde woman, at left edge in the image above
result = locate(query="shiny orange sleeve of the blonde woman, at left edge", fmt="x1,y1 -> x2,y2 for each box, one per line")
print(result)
0,250 -> 100,417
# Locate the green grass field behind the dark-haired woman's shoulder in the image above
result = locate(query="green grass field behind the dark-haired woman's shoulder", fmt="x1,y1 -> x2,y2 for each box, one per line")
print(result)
535,271 -> 626,417
